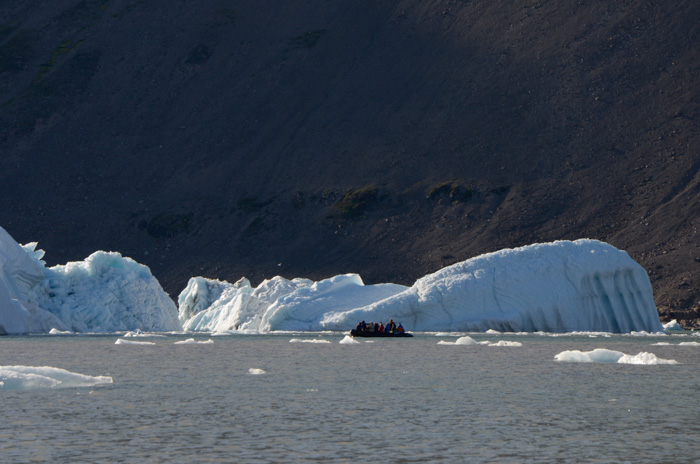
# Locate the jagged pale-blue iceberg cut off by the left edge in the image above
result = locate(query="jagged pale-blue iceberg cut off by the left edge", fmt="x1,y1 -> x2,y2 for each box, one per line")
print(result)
0,227 -> 181,333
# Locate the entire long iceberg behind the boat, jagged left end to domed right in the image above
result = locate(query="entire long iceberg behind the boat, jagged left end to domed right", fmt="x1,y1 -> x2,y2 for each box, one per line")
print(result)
180,240 -> 662,332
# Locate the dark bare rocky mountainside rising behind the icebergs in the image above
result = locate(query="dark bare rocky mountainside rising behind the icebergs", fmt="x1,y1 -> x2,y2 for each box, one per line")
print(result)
0,0 -> 700,325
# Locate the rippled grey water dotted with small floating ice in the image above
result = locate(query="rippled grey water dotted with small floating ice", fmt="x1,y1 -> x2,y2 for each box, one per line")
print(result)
0,334 -> 700,463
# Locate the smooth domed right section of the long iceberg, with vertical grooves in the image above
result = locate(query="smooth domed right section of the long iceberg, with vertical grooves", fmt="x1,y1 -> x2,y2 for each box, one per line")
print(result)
320,239 -> 662,332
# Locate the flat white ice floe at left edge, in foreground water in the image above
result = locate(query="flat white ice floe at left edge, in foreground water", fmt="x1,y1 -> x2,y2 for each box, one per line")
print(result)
0,366 -> 112,390
